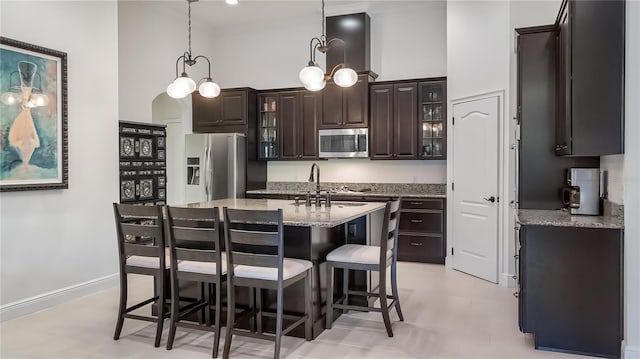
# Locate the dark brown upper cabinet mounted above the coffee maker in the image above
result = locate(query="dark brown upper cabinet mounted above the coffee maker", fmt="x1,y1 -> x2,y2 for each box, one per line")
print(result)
555,0 -> 625,156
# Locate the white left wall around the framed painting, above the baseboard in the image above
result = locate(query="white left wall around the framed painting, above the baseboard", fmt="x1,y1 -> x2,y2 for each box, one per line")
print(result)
0,1 -> 118,312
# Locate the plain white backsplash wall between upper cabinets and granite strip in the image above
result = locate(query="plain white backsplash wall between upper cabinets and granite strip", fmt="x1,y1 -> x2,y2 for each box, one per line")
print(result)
267,159 -> 447,183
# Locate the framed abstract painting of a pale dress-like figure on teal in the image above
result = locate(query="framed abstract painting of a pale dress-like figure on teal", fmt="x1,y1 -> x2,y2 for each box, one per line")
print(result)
0,37 -> 68,191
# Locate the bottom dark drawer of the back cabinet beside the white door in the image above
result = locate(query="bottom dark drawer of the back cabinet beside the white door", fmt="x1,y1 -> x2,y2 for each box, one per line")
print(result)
398,234 -> 445,264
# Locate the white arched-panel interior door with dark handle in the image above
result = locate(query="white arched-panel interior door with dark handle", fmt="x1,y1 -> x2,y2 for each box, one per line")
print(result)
452,95 -> 500,283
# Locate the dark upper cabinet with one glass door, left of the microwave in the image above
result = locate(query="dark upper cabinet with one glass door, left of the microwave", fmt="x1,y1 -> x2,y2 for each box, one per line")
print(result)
258,90 -> 322,160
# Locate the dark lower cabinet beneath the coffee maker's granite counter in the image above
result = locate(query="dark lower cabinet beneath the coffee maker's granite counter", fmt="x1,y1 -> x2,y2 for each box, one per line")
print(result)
518,226 -> 623,358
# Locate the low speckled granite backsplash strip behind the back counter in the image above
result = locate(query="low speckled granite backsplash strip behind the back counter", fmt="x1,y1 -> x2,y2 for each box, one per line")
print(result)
267,182 -> 447,194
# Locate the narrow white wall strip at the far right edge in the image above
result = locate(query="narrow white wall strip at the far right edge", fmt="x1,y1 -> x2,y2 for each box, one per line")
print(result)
624,0 -> 640,359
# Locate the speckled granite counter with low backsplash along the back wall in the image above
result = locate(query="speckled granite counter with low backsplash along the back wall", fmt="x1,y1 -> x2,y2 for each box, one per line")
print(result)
247,182 -> 447,198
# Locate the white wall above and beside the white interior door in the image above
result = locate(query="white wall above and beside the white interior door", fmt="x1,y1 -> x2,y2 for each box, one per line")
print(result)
447,1 -> 514,285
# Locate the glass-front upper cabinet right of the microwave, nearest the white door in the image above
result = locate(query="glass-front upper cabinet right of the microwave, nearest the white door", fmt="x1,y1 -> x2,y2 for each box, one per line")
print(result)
418,81 -> 447,159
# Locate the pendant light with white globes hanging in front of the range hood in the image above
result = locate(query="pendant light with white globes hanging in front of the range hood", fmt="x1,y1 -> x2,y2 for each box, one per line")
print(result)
298,0 -> 358,91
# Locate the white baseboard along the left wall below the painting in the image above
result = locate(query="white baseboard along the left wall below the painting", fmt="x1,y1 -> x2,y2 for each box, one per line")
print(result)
0,273 -> 118,322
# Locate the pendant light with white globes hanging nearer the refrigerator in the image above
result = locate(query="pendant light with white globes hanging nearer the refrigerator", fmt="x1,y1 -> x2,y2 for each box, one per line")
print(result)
167,0 -> 220,99
